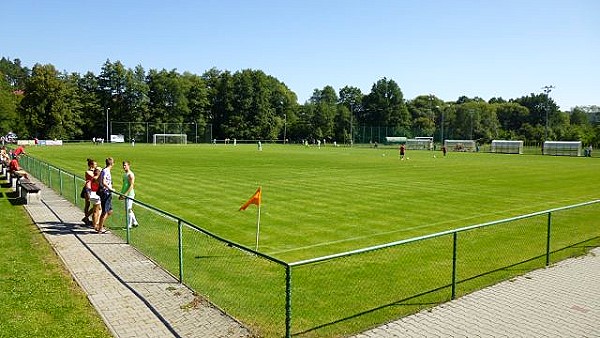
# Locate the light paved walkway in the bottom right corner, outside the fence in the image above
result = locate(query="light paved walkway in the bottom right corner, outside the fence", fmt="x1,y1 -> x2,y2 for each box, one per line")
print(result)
354,248 -> 600,338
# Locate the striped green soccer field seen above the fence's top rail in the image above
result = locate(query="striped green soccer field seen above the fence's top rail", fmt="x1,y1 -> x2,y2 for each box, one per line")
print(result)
27,144 -> 600,262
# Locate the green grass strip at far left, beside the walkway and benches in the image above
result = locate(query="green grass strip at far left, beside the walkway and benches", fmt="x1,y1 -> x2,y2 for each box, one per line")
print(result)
0,181 -> 111,338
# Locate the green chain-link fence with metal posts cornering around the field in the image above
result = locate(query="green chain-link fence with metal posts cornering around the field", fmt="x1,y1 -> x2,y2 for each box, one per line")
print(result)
16,156 -> 600,337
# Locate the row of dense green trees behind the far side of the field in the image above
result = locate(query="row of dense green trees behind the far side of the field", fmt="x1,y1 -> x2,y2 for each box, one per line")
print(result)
0,57 -> 600,145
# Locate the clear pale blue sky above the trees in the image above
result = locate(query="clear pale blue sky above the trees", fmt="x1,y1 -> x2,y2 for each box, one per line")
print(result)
0,0 -> 600,110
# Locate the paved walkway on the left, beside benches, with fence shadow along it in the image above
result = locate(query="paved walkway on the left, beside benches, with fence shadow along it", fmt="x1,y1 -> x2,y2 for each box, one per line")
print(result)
18,177 -> 250,338
